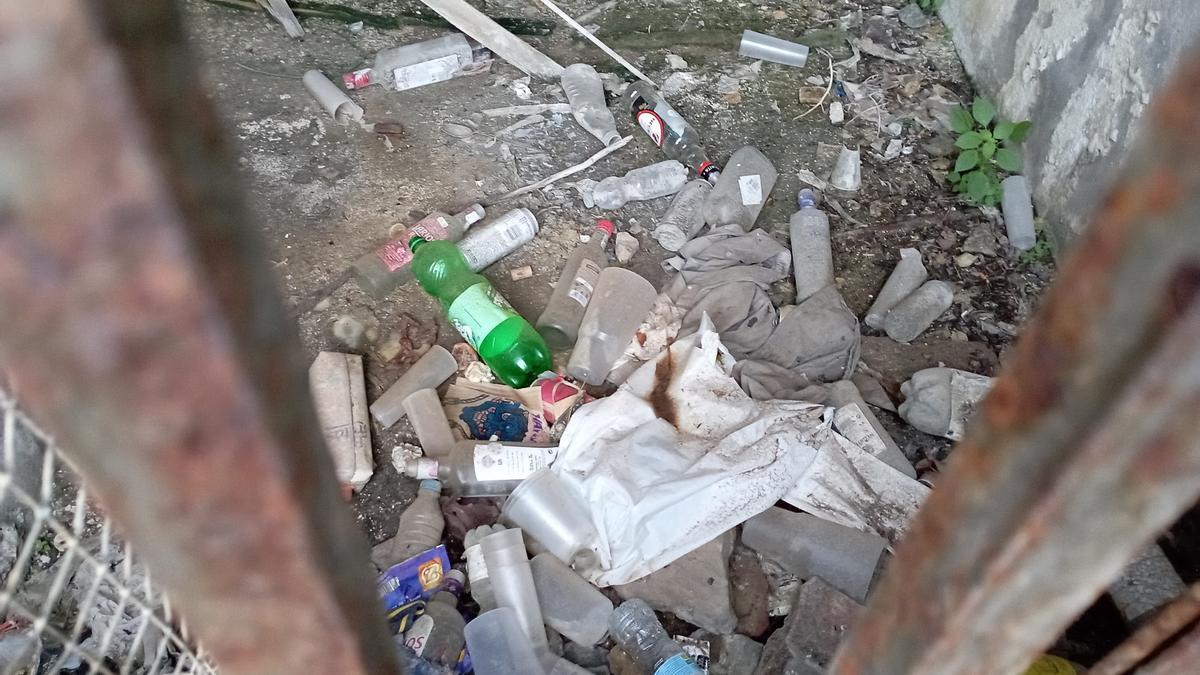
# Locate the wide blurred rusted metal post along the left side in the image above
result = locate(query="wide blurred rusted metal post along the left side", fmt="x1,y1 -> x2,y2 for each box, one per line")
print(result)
0,0 -> 400,675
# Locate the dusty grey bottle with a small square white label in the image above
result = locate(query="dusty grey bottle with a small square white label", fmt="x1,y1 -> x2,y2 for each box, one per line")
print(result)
704,145 -> 779,232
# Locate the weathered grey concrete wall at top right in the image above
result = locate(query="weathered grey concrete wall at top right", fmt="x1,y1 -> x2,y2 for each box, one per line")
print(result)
941,0 -> 1200,240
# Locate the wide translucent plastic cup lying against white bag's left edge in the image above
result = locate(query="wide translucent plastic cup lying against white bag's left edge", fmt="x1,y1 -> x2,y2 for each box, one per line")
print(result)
500,468 -> 599,567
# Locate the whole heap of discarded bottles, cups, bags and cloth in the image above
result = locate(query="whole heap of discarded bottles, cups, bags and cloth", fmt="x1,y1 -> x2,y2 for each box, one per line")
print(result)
290,2 -> 1032,675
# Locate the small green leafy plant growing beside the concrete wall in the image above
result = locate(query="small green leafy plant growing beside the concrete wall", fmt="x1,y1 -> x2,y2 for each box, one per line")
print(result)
947,97 -> 1033,207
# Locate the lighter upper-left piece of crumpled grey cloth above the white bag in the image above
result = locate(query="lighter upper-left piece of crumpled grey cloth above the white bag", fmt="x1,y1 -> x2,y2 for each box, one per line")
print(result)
664,225 -> 792,358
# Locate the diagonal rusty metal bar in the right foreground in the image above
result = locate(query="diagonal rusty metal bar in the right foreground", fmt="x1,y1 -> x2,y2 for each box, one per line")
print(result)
830,47 -> 1200,675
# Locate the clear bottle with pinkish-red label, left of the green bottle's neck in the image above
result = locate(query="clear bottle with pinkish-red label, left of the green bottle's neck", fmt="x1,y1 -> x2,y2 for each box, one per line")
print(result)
353,204 -> 484,298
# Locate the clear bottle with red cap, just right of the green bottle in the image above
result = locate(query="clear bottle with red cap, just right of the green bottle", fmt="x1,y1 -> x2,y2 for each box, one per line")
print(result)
534,220 -> 613,350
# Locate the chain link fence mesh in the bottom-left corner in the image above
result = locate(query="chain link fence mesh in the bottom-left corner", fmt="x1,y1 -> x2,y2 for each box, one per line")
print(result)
0,389 -> 216,675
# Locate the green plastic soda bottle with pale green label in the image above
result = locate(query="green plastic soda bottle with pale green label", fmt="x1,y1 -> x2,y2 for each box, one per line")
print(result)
409,237 -> 553,388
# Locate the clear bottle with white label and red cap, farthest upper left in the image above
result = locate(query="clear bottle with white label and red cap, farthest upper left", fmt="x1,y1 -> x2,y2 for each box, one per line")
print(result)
342,32 -> 492,91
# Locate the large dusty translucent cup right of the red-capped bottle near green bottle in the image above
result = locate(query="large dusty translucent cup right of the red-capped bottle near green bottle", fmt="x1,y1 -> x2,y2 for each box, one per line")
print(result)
566,267 -> 658,386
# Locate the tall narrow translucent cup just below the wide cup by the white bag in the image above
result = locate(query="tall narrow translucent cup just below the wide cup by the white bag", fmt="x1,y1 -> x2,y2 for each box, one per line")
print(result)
479,528 -> 550,653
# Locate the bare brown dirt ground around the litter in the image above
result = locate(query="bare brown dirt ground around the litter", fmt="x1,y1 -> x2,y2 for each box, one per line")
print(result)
185,0 -> 1052,542
